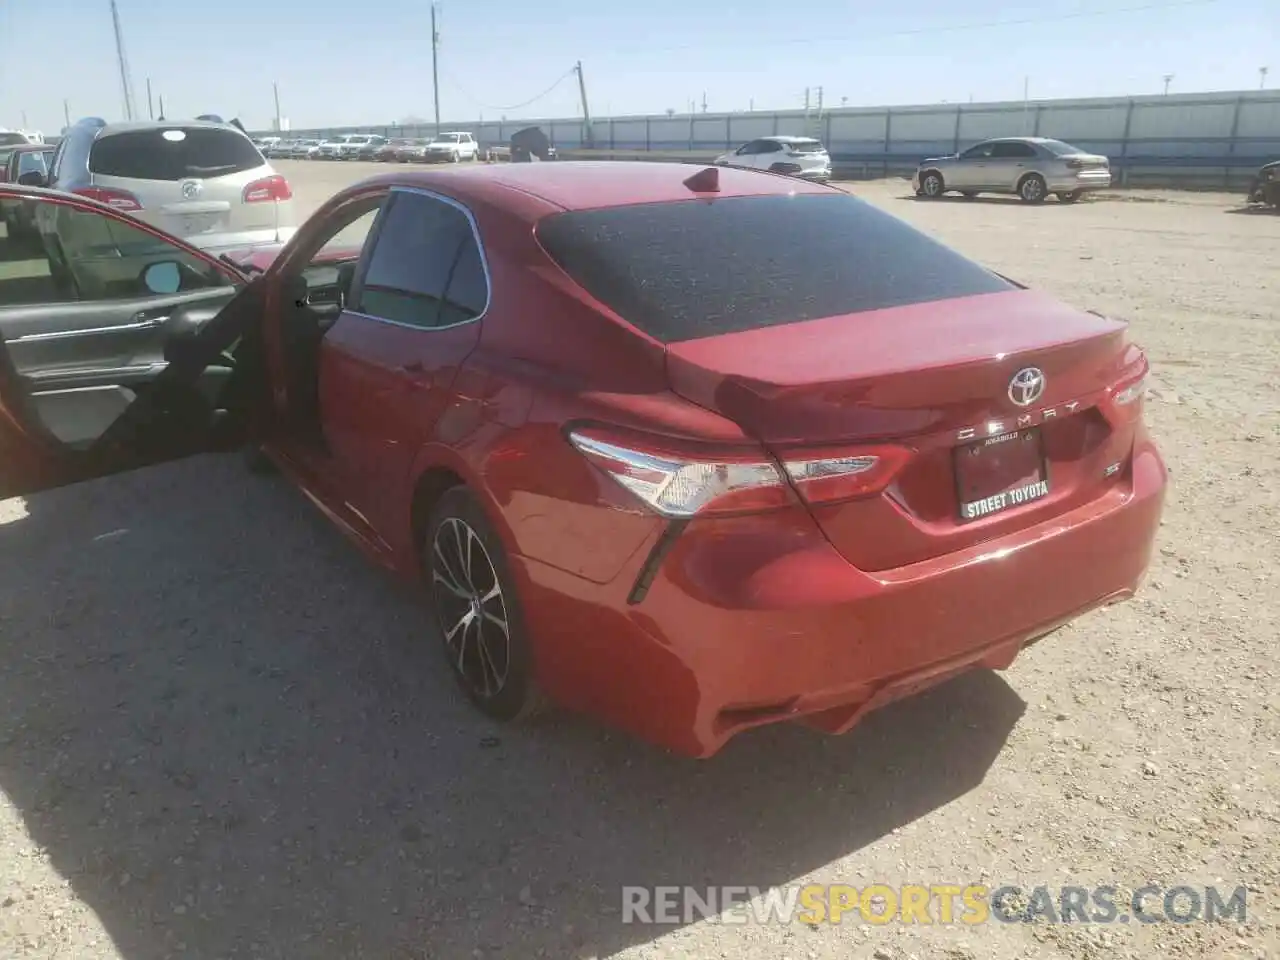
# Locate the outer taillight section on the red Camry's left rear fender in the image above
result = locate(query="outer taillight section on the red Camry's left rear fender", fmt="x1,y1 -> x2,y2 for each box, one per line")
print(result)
568,428 -> 795,518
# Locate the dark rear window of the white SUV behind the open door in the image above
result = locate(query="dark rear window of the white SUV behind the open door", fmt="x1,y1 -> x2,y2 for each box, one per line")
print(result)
88,127 -> 265,180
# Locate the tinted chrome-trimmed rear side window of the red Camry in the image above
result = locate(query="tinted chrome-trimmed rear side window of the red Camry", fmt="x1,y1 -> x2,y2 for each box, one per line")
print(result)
356,192 -> 489,329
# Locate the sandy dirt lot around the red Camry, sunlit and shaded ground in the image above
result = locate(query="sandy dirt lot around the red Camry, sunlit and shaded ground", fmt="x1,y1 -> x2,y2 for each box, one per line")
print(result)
0,164 -> 1280,960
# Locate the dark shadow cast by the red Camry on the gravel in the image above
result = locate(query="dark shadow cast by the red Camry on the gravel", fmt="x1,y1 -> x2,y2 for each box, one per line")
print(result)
0,457 -> 1024,960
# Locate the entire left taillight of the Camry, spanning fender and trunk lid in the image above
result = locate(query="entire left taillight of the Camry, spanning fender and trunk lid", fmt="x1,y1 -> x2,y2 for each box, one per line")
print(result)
570,428 -> 911,517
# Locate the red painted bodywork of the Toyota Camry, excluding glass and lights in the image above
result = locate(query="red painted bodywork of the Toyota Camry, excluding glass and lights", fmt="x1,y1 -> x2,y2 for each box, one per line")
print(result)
0,171 -> 1166,756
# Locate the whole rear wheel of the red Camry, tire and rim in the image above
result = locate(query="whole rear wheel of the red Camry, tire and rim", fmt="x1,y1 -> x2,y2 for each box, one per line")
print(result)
419,486 -> 545,723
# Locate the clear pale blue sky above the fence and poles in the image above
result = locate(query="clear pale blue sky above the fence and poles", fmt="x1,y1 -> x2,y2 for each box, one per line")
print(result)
0,0 -> 1280,133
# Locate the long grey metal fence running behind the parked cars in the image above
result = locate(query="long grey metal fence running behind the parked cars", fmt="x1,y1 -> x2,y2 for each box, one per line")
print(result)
264,91 -> 1280,186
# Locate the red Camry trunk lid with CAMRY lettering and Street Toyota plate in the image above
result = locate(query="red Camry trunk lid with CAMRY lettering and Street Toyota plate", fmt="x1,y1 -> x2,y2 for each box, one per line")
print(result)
667,291 -> 1132,571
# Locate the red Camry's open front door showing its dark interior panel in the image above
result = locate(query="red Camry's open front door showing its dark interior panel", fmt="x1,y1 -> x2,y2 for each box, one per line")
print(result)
0,184 -> 266,497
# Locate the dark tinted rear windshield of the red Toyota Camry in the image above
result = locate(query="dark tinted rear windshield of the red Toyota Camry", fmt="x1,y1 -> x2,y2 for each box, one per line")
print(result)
538,193 -> 1015,343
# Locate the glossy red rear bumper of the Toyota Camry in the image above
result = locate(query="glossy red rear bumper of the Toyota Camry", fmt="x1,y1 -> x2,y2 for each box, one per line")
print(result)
515,439 -> 1166,756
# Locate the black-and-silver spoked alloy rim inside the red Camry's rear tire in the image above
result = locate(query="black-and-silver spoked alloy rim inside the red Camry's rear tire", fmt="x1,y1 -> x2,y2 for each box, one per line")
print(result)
431,517 -> 511,700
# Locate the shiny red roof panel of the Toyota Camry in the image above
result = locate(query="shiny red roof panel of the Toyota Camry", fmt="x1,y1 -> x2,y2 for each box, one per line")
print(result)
348,160 -> 840,219
